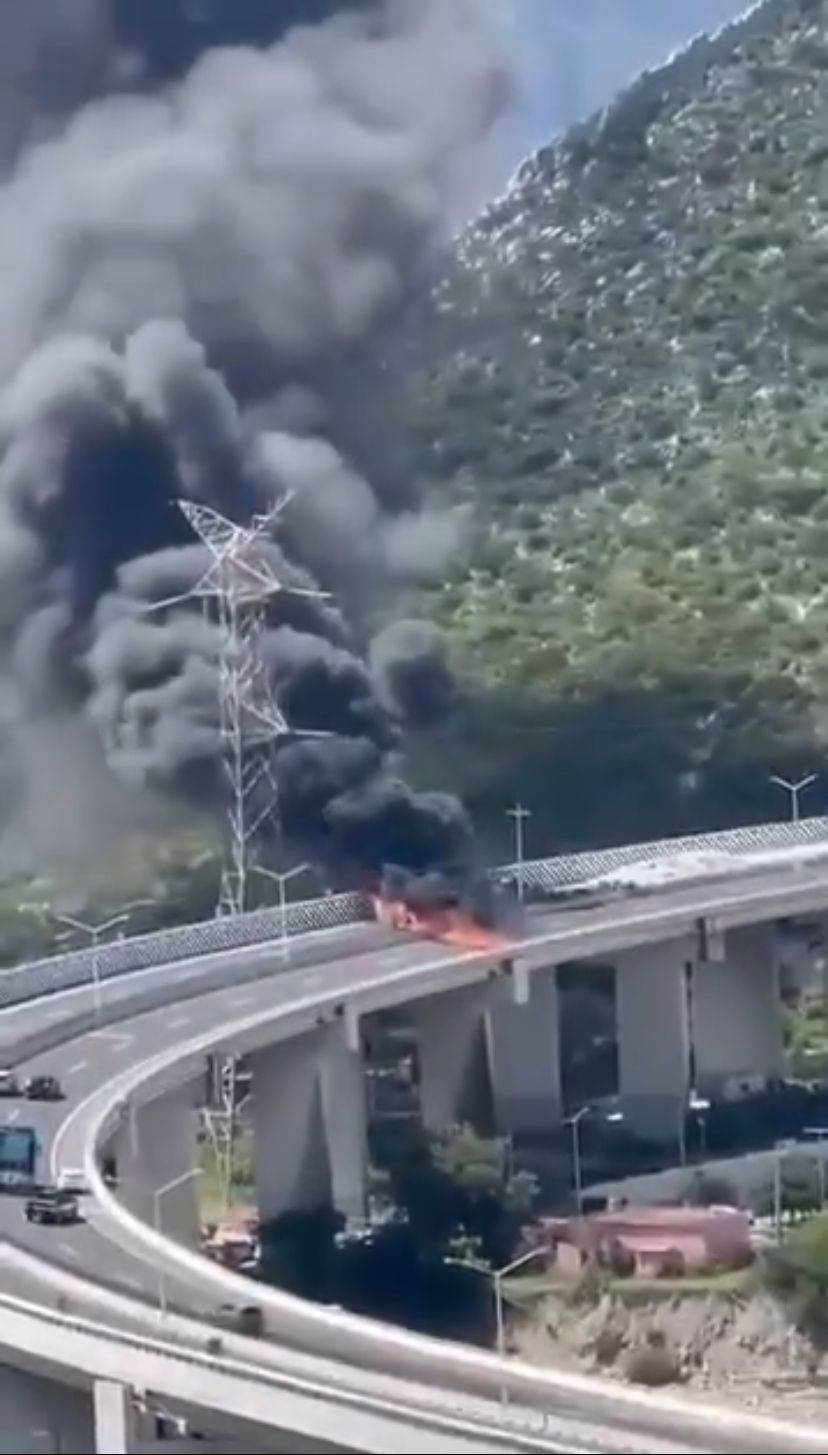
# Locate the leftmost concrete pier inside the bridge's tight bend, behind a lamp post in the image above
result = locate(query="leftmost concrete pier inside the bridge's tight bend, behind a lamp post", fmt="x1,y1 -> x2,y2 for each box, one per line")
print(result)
114,1083 -> 199,1244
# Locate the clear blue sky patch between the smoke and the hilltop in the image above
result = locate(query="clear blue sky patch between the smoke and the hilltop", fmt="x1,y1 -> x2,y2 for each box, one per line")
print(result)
494,0 -> 749,164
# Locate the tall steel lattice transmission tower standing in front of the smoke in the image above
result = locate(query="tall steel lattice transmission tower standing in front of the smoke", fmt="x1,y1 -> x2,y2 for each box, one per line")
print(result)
174,498 -> 326,915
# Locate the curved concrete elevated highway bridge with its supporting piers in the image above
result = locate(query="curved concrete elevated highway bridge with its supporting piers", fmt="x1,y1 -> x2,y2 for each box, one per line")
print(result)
0,826 -> 828,1452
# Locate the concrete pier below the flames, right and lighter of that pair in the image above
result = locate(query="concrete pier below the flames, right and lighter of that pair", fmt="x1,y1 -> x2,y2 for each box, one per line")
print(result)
489,966 -> 563,1136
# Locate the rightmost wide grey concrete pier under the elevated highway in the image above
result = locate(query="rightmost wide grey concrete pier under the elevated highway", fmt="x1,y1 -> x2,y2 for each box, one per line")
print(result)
693,924 -> 784,1096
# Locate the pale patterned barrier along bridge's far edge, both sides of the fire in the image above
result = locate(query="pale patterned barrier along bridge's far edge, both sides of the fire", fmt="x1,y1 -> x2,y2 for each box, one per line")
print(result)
0,818 -> 828,1010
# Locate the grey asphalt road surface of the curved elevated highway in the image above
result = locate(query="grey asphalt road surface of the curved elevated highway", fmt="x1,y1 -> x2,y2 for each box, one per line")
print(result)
0,867 -> 828,1455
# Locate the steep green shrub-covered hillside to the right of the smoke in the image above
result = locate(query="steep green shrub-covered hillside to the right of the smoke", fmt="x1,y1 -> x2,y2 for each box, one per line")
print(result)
415,0 -> 828,847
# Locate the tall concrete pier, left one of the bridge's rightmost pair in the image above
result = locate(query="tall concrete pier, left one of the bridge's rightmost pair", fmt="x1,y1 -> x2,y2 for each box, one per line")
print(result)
616,938 -> 694,1144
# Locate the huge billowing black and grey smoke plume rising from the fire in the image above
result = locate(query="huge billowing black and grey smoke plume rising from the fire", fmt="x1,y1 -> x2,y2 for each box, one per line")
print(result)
0,0 -> 505,870
